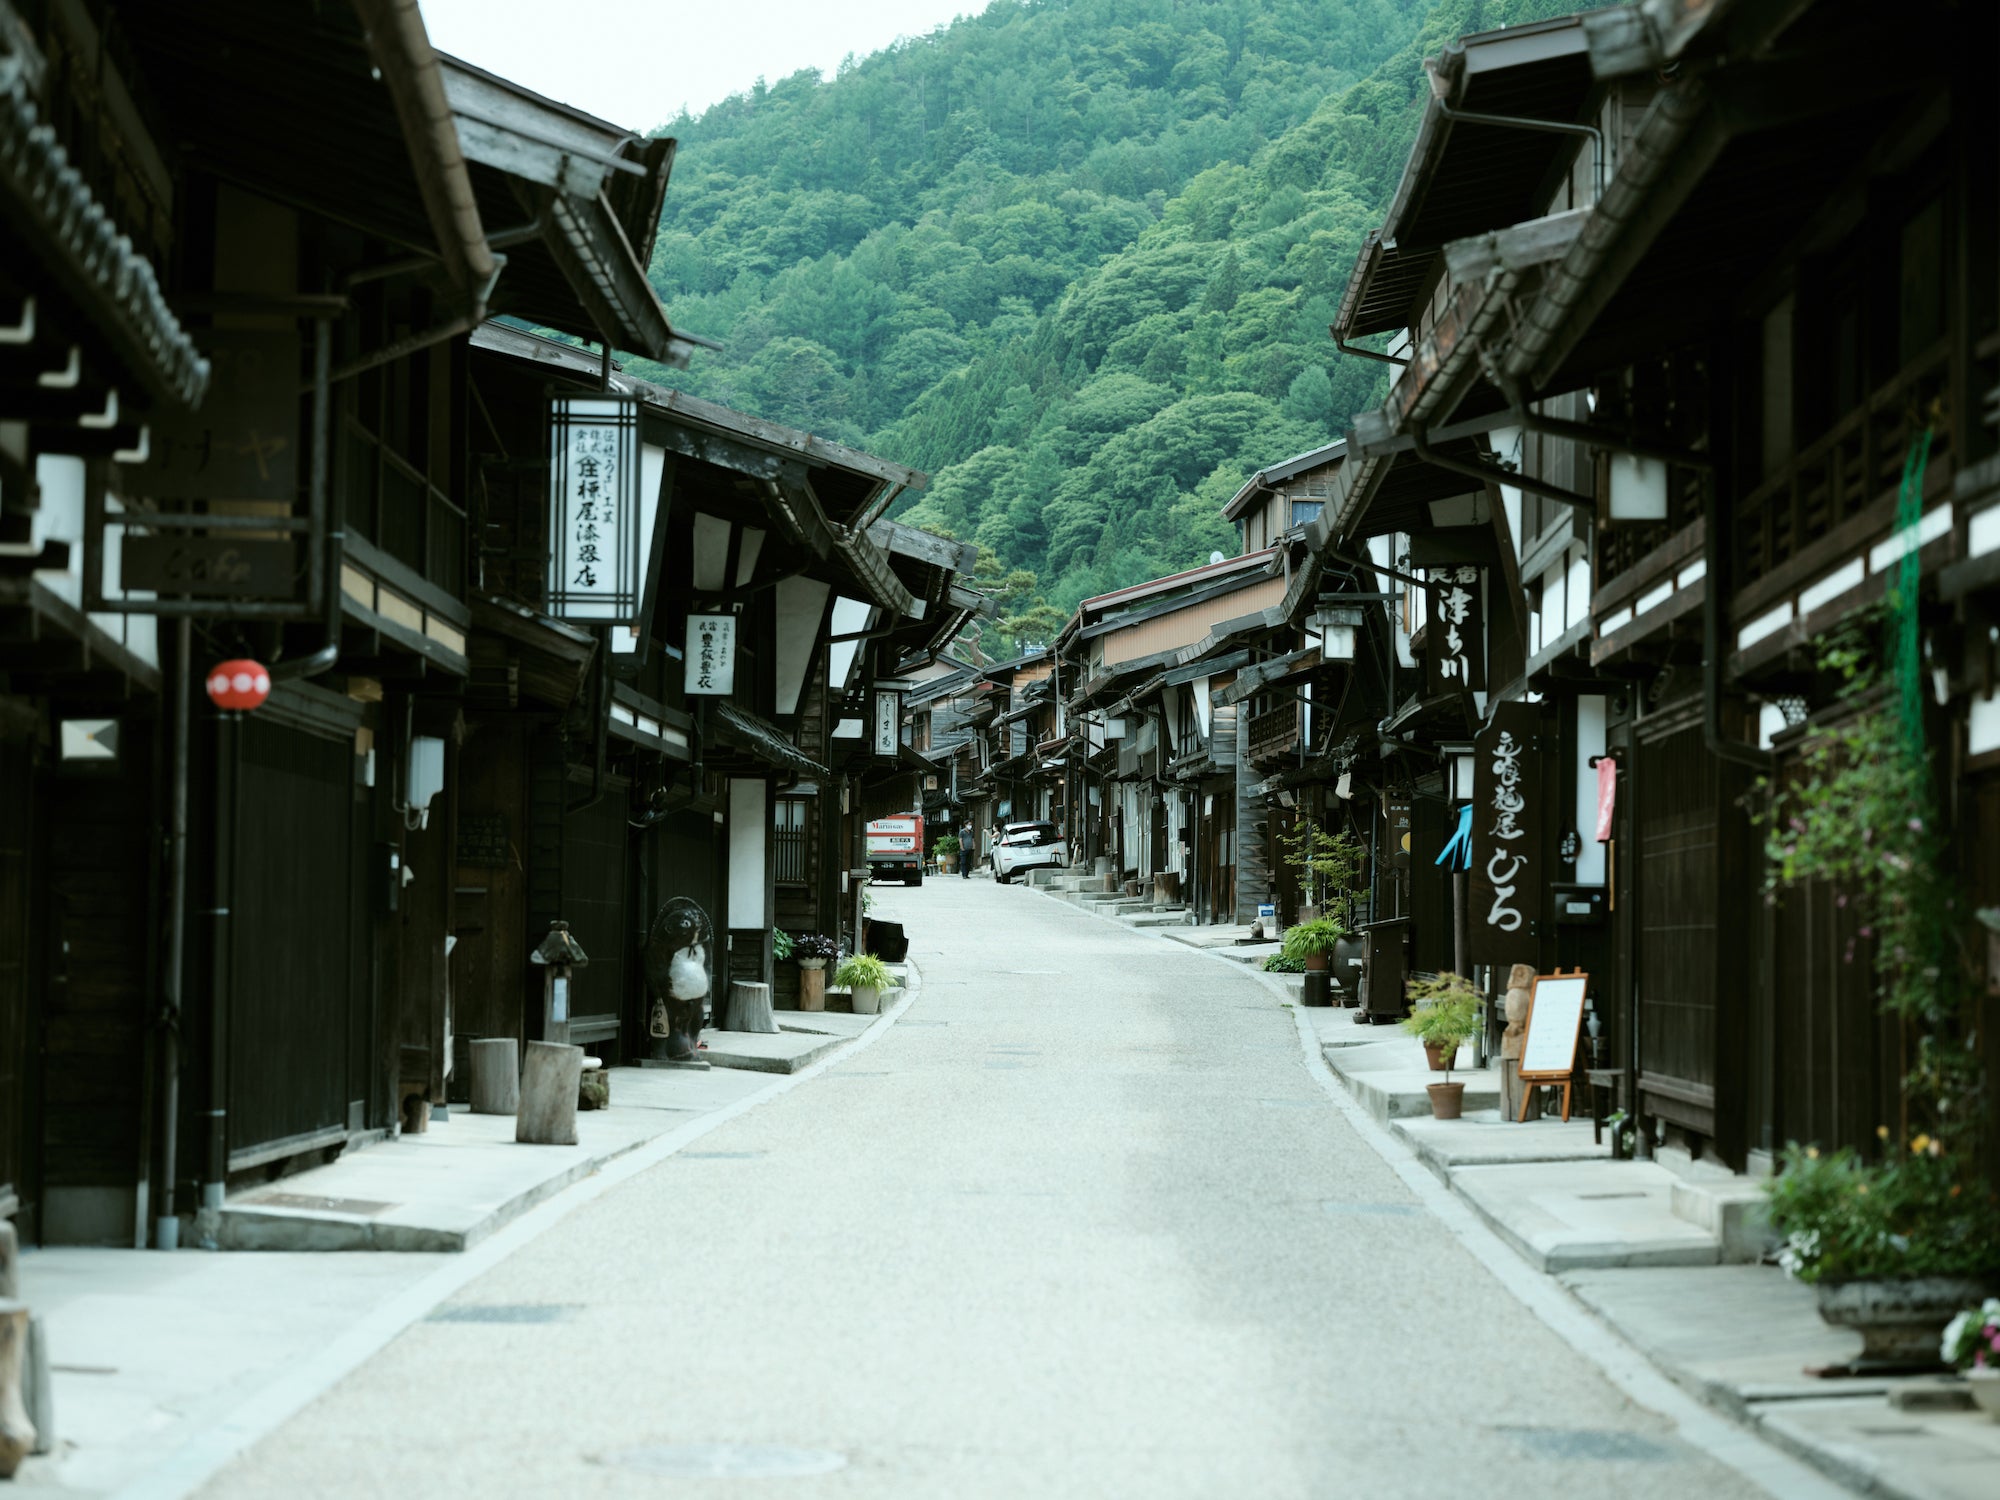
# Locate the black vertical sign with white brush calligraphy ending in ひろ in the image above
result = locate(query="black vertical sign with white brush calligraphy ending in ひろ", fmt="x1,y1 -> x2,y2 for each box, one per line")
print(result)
1470,704 -> 1546,964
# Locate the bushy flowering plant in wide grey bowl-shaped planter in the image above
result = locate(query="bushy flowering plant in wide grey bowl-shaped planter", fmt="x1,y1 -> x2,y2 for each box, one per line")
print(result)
1766,1130 -> 2000,1368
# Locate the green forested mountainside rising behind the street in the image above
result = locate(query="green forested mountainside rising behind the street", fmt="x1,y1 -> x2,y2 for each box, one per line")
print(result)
632,0 -> 1578,634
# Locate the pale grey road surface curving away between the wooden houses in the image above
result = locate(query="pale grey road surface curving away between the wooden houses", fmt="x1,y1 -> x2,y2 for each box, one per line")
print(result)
204,878 -> 1756,1500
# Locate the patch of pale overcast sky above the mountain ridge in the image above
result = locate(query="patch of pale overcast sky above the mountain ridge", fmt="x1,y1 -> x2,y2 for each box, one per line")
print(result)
422,0 -> 986,130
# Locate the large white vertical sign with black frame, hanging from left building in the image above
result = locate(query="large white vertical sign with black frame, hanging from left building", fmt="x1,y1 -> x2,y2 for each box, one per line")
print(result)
546,392 -> 650,624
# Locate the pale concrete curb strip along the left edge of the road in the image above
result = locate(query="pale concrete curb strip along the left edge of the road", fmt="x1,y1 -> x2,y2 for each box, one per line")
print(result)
110,962 -> 924,1500
